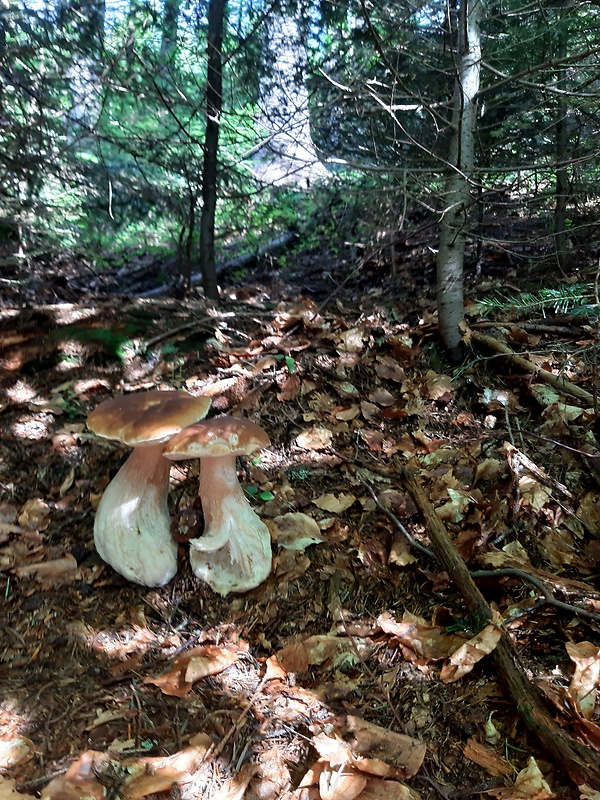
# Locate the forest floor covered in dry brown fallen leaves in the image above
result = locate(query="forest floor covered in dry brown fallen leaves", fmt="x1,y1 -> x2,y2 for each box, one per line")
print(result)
0,227 -> 600,800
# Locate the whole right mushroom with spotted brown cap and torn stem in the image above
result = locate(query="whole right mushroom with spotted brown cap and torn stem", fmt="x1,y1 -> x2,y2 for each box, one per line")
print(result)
164,417 -> 272,595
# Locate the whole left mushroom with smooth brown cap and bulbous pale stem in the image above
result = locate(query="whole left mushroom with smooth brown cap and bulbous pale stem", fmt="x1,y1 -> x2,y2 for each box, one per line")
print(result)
87,390 -> 210,586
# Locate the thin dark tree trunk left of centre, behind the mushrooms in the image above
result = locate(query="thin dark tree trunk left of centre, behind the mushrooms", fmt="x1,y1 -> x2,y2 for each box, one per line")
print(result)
200,0 -> 227,300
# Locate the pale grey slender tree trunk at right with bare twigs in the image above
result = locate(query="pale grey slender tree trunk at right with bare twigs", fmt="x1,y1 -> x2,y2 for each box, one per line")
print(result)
437,0 -> 482,360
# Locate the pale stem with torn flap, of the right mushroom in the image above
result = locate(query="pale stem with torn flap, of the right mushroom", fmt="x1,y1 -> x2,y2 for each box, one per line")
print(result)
190,455 -> 272,595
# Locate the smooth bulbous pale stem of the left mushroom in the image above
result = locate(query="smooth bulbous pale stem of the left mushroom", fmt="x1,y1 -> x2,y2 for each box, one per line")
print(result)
94,443 -> 177,586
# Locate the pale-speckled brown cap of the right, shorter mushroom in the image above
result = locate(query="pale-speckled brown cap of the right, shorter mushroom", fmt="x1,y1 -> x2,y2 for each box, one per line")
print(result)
163,417 -> 271,461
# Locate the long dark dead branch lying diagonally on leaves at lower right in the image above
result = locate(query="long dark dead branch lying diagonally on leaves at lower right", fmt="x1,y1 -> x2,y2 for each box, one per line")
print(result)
401,466 -> 600,790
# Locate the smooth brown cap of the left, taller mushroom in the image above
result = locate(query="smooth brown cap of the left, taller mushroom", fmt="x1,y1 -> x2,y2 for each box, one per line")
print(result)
87,389 -> 211,447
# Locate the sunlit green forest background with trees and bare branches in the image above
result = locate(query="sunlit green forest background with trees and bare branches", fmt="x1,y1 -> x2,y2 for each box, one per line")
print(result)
0,0 -> 600,346
